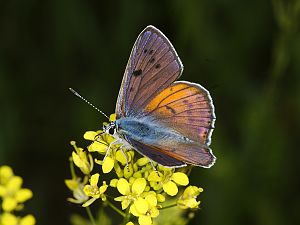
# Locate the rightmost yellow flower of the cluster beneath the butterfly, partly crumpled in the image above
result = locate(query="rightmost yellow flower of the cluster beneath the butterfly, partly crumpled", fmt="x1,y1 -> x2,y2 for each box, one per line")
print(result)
177,186 -> 203,209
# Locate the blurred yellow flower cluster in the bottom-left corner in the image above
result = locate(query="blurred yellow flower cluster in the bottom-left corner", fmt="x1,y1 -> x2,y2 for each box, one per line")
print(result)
0,165 -> 35,225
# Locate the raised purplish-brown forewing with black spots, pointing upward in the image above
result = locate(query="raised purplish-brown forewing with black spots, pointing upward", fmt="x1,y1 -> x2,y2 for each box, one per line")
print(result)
116,26 -> 183,119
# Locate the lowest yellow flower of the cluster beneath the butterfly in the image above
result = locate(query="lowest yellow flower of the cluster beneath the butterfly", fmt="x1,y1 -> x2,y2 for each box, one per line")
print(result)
130,192 -> 159,225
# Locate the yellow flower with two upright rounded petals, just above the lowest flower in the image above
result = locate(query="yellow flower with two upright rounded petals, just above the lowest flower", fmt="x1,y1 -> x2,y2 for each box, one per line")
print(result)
115,178 -> 147,210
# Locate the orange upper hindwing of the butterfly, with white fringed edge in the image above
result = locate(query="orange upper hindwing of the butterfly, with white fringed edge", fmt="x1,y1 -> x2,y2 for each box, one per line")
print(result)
144,81 -> 215,146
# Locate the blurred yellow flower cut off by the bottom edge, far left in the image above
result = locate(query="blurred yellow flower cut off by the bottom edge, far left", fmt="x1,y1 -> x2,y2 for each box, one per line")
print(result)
0,213 -> 36,225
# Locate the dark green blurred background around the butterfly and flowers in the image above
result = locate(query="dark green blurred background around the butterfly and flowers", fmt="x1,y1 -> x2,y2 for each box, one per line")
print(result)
0,0 -> 300,225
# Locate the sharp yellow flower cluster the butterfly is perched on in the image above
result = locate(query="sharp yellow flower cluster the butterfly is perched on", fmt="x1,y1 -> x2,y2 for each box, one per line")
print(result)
65,114 -> 202,225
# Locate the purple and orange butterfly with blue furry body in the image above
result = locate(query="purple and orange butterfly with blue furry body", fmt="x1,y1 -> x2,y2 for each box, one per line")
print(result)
104,26 -> 216,168
